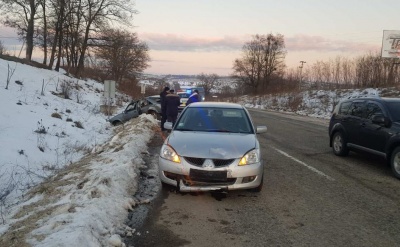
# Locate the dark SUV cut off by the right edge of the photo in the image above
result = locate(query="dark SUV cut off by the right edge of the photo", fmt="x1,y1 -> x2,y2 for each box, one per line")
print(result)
329,97 -> 400,179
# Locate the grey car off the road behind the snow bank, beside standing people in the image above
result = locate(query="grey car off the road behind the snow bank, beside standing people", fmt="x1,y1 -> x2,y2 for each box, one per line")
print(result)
108,95 -> 161,125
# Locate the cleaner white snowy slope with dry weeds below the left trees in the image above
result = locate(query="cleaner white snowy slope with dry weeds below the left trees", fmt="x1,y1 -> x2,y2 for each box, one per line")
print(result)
0,60 -> 111,208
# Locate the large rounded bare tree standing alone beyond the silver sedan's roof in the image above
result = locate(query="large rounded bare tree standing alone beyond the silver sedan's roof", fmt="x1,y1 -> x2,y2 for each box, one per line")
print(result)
233,34 -> 286,93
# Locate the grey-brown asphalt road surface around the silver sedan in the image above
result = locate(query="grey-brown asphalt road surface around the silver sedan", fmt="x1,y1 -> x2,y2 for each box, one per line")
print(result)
126,110 -> 400,247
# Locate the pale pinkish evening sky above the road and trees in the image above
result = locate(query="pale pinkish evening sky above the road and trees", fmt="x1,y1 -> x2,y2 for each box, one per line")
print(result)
0,0 -> 400,75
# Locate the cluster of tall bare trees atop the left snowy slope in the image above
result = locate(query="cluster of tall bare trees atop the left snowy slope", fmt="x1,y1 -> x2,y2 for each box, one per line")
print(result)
0,0 -> 150,85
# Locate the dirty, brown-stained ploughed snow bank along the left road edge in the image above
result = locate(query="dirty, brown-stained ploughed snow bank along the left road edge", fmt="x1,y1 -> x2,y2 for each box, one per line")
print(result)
0,115 -> 157,247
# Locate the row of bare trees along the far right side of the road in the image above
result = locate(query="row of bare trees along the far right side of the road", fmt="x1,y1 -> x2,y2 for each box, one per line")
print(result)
232,34 -> 400,94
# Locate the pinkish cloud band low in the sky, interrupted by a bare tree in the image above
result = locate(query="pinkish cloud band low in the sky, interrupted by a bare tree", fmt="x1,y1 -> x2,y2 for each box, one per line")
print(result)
139,33 -> 380,52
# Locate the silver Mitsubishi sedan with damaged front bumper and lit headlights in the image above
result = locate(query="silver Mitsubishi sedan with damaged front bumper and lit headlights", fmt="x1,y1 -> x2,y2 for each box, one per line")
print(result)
159,102 -> 267,192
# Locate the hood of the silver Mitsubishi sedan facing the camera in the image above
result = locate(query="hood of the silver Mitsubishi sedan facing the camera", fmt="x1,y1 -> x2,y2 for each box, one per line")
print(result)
166,131 -> 258,159
